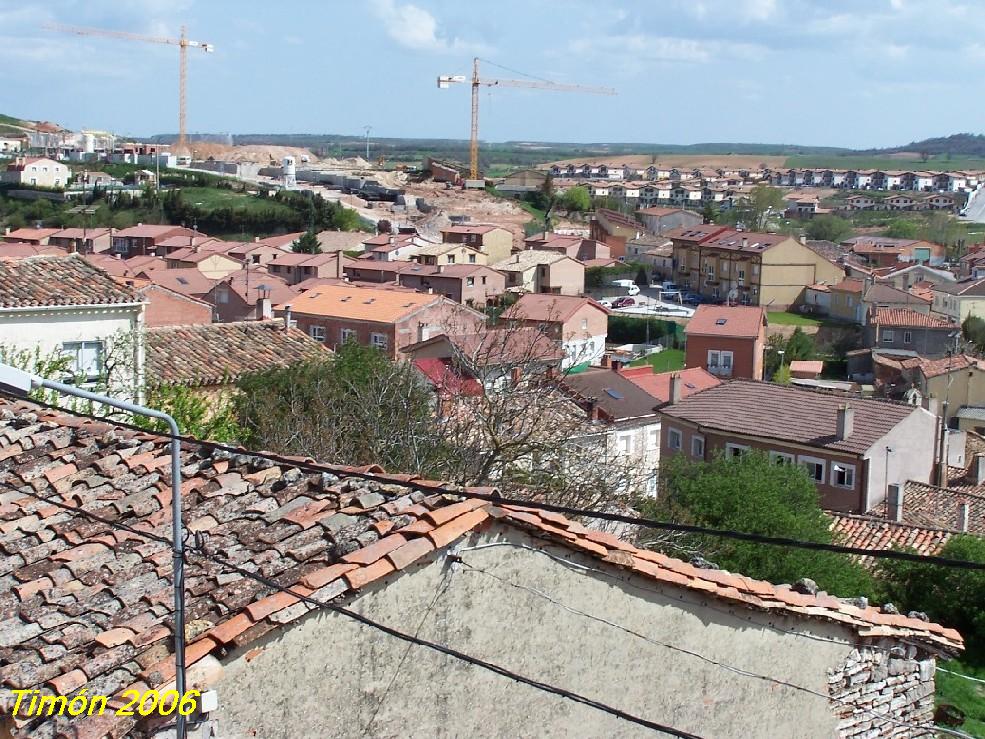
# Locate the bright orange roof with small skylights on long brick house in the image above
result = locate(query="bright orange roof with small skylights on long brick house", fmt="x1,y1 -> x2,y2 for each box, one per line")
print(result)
277,285 -> 446,323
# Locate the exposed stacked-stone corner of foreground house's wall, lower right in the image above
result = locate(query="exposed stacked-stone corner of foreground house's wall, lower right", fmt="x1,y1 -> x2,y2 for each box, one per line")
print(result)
828,643 -> 937,739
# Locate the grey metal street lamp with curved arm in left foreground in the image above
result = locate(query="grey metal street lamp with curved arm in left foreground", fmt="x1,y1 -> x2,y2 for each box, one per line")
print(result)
0,363 -> 186,739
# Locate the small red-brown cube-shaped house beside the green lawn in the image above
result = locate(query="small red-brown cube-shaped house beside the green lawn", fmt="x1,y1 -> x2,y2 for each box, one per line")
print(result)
684,305 -> 768,380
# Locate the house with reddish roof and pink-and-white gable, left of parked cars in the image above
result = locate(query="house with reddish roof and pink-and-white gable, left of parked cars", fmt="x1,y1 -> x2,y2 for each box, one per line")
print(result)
502,293 -> 609,369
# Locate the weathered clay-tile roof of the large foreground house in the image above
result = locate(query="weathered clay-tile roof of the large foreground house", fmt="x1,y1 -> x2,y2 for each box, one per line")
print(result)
0,402 -> 962,737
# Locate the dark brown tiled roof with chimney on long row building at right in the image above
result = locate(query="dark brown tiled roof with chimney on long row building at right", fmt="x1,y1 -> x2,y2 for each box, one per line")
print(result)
662,380 -> 927,454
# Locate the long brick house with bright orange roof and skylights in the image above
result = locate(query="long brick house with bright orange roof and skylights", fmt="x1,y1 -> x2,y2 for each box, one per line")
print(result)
277,285 -> 485,359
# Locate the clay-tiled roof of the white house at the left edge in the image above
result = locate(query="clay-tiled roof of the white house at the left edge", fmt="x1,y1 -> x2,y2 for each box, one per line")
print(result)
0,254 -> 141,308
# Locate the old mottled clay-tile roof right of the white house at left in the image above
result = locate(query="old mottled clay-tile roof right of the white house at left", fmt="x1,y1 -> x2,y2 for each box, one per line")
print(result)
146,321 -> 326,386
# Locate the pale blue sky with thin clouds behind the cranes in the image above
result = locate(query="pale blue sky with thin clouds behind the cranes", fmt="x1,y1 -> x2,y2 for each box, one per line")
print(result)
0,0 -> 985,148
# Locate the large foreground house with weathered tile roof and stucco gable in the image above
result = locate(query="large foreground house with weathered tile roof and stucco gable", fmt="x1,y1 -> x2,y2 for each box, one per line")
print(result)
0,391 -> 962,739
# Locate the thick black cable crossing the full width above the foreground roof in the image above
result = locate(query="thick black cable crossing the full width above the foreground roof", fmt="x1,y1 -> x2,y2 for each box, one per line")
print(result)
0,390 -> 985,571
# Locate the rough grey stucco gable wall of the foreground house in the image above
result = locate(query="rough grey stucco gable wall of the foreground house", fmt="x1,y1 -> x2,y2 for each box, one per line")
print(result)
214,527 -> 868,739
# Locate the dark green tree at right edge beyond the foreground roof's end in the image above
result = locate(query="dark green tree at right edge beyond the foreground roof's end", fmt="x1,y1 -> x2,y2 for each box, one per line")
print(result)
879,535 -> 985,659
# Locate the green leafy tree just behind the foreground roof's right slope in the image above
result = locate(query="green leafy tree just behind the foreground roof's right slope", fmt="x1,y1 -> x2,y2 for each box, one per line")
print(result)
642,452 -> 874,596
